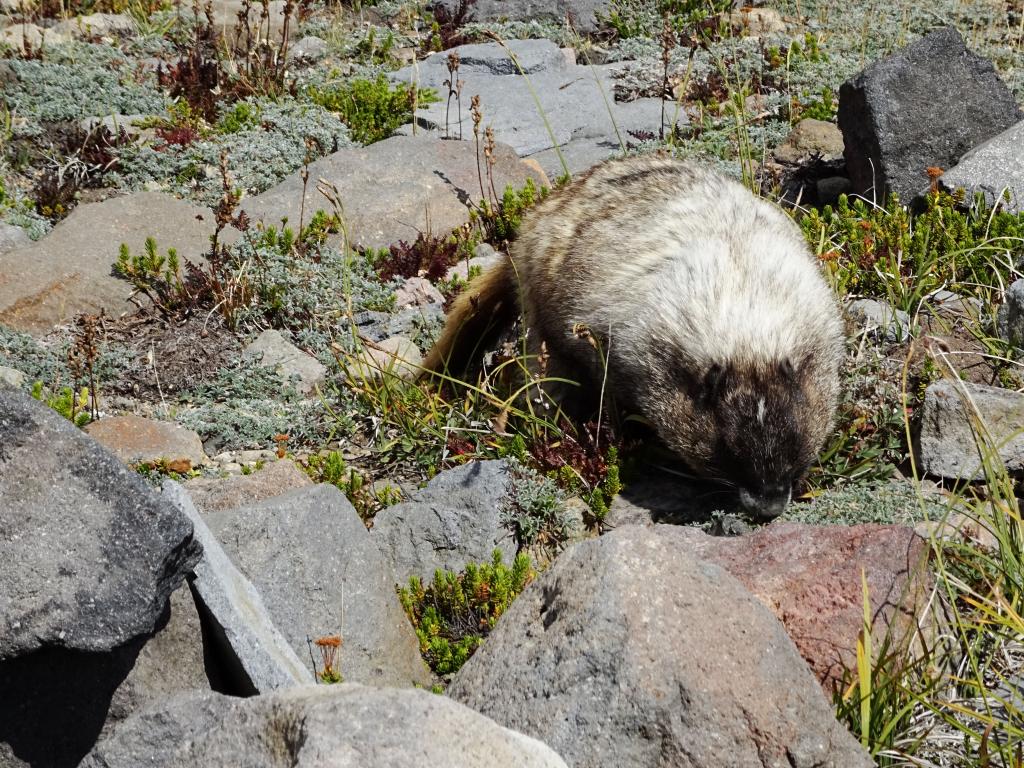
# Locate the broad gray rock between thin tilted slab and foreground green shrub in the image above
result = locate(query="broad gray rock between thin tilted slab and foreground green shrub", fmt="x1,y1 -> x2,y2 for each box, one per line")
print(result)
206,485 -> 430,686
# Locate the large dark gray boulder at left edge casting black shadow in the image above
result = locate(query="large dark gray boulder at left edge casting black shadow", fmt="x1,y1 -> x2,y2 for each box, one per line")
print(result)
0,386 -> 201,659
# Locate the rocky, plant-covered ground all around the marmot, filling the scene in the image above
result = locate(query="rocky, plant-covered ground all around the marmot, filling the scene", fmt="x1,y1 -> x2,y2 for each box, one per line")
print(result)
0,0 -> 1024,767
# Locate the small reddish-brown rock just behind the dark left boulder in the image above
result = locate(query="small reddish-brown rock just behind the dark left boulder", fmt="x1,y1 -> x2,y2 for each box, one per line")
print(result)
85,416 -> 208,473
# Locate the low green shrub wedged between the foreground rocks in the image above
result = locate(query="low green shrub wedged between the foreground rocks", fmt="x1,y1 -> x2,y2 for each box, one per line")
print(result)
398,550 -> 535,675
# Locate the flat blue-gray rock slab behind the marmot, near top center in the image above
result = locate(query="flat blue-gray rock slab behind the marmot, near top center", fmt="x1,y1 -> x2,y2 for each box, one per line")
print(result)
392,40 -> 663,175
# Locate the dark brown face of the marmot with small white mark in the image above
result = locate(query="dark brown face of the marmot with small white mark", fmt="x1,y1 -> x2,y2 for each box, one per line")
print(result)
702,360 -> 816,519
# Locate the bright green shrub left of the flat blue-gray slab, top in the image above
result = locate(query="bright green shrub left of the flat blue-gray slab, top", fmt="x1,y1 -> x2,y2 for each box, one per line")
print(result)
307,75 -> 437,144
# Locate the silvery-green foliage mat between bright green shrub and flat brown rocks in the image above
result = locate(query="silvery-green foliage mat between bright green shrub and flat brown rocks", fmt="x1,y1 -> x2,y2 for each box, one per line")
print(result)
109,97 -> 353,206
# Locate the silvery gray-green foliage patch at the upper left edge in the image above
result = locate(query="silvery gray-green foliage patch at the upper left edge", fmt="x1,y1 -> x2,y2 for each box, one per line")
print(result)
2,43 -> 167,125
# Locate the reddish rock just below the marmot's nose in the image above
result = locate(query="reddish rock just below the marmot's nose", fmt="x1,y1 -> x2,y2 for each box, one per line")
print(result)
675,522 -> 930,691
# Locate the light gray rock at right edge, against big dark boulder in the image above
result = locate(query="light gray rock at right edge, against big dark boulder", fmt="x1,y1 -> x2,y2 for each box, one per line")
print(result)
939,121 -> 1024,213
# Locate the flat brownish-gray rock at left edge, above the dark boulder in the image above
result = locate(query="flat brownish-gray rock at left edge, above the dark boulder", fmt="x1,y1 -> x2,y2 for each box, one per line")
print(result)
0,193 -> 222,335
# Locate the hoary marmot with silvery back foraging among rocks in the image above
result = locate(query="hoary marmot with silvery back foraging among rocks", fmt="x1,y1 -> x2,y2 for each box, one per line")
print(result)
424,157 -> 844,518
